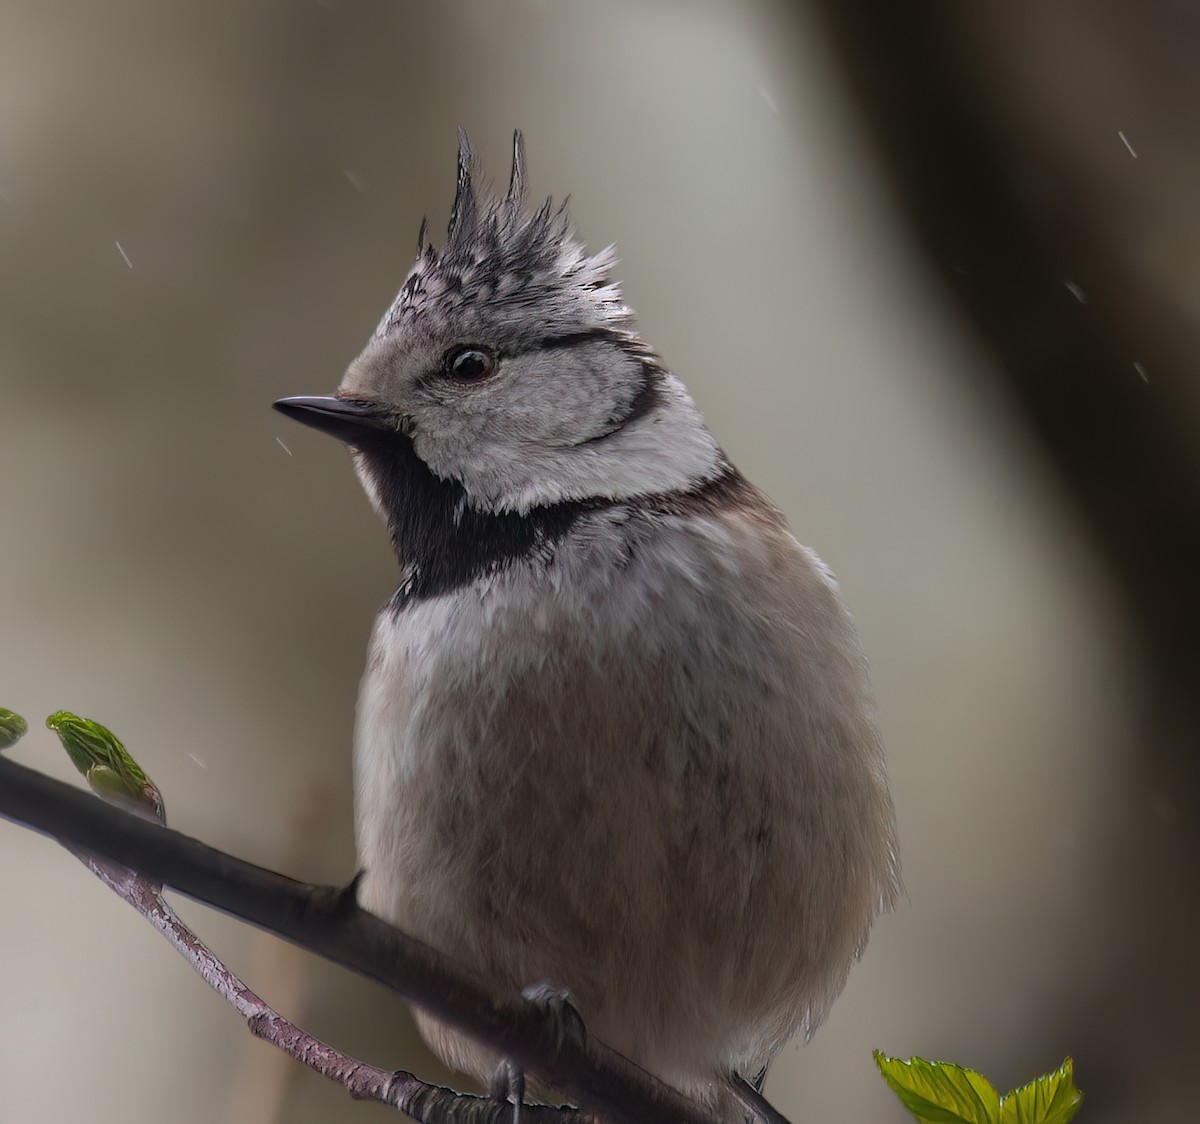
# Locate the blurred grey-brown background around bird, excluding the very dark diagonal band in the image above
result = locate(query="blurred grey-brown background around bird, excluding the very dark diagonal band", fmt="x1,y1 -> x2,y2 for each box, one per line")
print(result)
0,0 -> 1200,1124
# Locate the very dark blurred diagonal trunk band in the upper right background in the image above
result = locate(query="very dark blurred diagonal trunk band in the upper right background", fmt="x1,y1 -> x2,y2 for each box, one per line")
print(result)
804,0 -> 1200,700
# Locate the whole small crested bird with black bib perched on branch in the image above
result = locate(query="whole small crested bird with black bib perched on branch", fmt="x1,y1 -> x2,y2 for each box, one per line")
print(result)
275,131 -> 900,1112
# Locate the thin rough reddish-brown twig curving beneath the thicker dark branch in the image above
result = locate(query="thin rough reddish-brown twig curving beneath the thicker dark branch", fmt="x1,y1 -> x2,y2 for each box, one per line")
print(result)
67,846 -> 580,1124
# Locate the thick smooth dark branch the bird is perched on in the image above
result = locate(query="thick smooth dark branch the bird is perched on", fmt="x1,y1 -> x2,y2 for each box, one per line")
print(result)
0,757 -> 720,1124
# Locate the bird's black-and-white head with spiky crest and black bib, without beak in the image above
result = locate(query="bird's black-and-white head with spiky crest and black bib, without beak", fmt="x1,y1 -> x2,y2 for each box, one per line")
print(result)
338,133 -> 730,599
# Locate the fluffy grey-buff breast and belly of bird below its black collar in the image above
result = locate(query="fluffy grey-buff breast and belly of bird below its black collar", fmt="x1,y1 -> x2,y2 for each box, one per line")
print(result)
345,503 -> 890,1074
